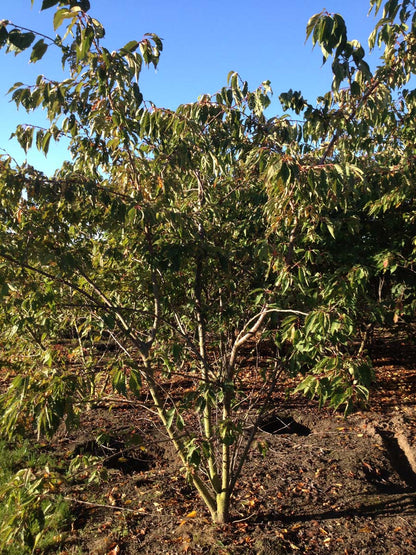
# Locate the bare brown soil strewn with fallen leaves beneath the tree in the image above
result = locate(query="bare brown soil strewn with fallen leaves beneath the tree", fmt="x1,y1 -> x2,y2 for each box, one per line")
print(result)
44,339 -> 416,555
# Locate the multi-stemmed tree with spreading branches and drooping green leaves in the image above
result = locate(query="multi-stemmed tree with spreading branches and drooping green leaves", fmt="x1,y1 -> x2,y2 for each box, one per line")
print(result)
0,0 -> 416,522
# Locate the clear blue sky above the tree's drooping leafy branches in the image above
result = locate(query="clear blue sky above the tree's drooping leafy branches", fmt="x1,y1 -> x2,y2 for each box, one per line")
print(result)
0,0 -> 382,173
